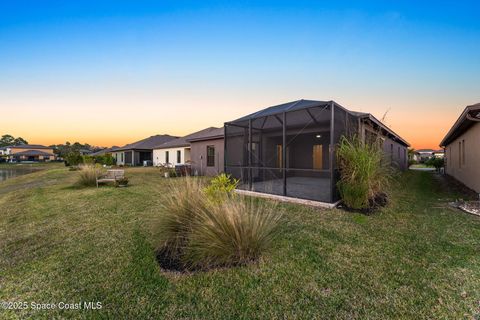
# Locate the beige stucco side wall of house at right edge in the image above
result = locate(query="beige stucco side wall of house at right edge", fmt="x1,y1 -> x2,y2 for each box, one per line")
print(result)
445,123 -> 480,193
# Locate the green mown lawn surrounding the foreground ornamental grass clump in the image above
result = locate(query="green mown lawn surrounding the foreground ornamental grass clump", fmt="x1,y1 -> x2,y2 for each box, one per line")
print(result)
0,166 -> 480,319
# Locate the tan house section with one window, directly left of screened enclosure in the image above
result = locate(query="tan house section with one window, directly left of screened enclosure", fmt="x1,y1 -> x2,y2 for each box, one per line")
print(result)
187,127 -> 225,176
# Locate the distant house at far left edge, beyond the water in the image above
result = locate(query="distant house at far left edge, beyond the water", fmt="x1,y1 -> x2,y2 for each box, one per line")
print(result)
3,144 -> 55,162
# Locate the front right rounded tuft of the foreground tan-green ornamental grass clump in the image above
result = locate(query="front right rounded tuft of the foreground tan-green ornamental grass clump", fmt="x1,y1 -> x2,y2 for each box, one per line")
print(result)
184,197 -> 280,269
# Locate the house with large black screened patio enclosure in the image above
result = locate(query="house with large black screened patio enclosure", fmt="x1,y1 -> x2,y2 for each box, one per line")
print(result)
224,100 -> 409,203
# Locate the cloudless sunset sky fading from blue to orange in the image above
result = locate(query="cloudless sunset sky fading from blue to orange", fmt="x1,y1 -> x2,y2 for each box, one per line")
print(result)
0,0 -> 480,149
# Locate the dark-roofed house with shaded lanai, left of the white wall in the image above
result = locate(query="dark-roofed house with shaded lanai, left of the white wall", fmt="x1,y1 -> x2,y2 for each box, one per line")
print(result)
112,134 -> 178,166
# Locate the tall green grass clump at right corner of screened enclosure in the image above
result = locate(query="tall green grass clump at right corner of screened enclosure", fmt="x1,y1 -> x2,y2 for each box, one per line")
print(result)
337,136 -> 393,209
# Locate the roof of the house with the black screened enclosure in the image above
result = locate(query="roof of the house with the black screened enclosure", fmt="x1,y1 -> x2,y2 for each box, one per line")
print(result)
226,99 -> 410,147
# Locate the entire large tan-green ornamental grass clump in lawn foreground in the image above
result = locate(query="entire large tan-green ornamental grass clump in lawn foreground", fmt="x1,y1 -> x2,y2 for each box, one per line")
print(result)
154,177 -> 281,270
